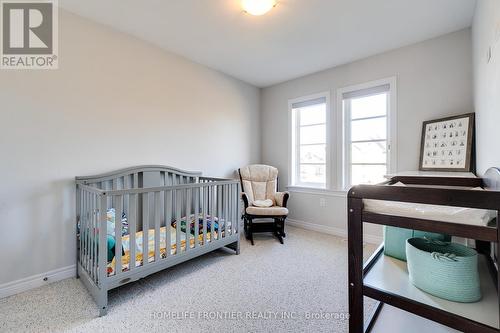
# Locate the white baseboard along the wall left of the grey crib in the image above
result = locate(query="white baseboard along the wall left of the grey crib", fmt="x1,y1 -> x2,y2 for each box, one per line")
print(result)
0,265 -> 76,298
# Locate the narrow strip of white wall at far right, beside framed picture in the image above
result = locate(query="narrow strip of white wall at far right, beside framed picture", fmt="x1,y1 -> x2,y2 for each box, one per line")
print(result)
472,0 -> 500,174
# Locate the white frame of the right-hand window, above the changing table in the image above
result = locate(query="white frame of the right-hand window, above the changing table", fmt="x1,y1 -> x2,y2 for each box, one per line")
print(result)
337,77 -> 397,190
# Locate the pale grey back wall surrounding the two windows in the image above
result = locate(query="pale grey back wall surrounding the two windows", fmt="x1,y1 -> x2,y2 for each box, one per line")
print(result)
261,29 -> 473,236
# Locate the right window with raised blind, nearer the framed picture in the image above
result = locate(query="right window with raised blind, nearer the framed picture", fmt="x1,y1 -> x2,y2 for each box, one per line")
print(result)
341,83 -> 391,188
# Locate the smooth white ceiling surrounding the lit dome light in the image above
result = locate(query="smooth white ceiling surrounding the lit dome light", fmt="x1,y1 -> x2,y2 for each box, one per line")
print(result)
59,0 -> 476,87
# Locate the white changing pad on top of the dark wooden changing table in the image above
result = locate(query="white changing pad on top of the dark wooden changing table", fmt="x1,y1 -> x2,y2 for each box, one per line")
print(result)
363,183 -> 496,226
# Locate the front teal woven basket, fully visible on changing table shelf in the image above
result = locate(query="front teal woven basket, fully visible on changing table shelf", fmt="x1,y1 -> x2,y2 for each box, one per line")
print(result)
406,238 -> 481,303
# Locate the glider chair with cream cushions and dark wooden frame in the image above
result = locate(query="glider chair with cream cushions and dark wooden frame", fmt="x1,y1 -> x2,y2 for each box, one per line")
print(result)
238,164 -> 290,245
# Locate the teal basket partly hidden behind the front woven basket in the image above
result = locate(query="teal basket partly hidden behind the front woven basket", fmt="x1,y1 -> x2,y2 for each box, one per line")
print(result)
384,226 -> 451,261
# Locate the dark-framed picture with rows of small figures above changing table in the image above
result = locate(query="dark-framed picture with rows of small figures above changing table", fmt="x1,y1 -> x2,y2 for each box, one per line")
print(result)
419,113 -> 475,172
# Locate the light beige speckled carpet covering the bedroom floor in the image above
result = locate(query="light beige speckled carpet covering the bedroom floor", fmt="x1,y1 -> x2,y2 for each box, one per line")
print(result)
0,227 -> 374,332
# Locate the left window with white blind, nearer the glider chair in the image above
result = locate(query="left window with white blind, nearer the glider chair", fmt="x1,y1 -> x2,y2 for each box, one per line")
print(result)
289,94 -> 330,188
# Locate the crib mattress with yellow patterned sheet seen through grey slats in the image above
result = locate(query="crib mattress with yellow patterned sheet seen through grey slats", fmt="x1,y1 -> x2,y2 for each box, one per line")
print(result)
107,222 -> 231,276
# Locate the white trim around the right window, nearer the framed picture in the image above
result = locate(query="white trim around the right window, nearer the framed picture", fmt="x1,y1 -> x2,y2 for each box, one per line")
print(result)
336,76 -> 398,190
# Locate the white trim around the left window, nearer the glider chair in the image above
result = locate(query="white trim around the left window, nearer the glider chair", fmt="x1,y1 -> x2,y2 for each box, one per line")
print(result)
288,91 -> 334,190
